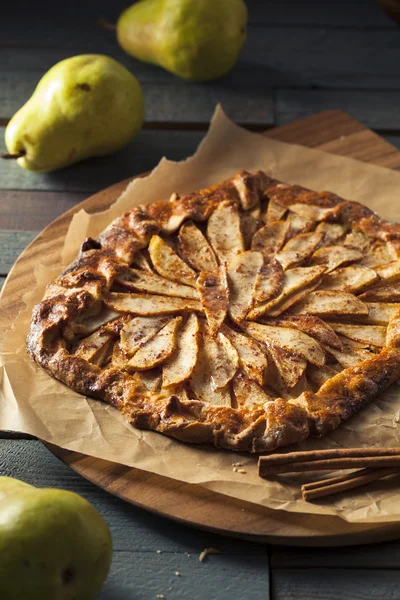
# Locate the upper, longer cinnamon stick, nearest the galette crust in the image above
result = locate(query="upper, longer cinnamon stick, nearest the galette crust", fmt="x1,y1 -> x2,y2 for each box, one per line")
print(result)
259,454 -> 400,477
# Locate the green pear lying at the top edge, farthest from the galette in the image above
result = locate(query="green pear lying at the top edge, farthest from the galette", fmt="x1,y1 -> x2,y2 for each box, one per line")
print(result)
117,0 -> 247,81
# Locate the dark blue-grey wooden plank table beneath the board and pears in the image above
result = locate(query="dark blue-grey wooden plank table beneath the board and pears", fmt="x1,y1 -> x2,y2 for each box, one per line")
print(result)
0,0 -> 400,600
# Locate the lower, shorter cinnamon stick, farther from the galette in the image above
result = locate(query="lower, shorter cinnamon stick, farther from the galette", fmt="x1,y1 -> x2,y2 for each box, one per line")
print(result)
301,467 -> 400,502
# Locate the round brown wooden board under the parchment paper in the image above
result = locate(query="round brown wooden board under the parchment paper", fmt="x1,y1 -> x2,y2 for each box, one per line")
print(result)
1,111 -> 400,545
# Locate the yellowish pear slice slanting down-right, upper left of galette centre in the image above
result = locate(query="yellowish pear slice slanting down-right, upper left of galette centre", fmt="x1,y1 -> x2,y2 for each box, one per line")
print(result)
149,235 -> 196,287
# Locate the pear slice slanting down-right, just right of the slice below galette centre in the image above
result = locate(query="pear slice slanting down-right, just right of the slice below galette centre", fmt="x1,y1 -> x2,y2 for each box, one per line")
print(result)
222,325 -> 268,385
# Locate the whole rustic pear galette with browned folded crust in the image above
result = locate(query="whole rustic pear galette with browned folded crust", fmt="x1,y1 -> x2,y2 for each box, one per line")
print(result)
28,171 -> 400,452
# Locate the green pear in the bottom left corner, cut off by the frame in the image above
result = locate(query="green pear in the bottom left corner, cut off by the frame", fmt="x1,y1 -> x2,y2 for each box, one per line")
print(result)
0,477 -> 112,600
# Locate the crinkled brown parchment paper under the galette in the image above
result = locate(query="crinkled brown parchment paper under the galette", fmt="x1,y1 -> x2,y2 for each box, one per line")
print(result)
0,109 -> 400,523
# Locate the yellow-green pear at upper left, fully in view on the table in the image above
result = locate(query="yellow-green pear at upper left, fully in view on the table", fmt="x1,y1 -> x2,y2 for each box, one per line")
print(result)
5,54 -> 144,172
